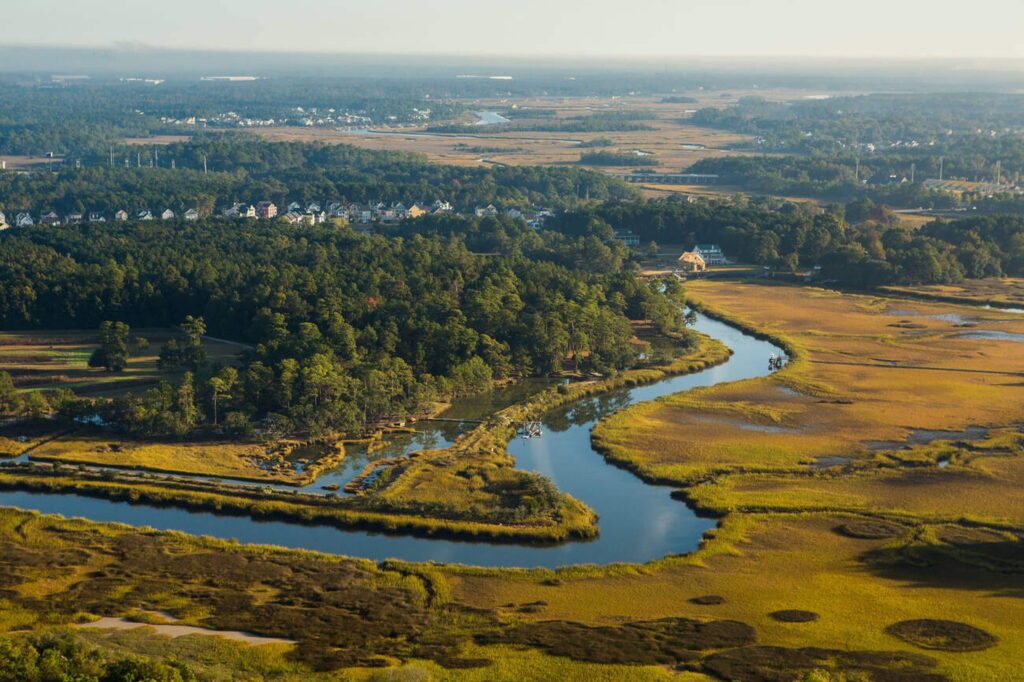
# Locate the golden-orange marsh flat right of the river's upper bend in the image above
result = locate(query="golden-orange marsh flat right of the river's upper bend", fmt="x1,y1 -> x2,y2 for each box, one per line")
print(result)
595,280 -> 1024,483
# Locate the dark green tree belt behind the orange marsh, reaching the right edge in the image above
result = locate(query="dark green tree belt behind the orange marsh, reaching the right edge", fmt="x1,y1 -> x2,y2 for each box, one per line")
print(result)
553,193 -> 1024,287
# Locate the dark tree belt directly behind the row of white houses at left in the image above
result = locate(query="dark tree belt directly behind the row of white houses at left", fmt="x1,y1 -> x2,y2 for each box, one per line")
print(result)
0,134 -> 633,218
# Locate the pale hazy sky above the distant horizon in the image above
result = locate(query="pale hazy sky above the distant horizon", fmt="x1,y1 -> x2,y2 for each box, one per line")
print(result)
8,0 -> 1024,58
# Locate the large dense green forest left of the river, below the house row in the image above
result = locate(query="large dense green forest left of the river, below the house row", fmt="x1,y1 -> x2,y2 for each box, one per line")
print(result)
0,217 -> 684,434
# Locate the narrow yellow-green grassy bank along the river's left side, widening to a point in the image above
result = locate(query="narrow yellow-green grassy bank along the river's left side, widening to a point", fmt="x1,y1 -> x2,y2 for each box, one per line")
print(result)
0,325 -> 729,545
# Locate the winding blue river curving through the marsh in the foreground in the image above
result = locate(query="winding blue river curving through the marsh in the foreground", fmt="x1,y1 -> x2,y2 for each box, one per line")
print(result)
0,315 -> 782,567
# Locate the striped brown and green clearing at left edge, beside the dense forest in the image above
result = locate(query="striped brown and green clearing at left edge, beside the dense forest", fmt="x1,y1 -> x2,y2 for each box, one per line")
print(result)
0,329 -> 240,397
